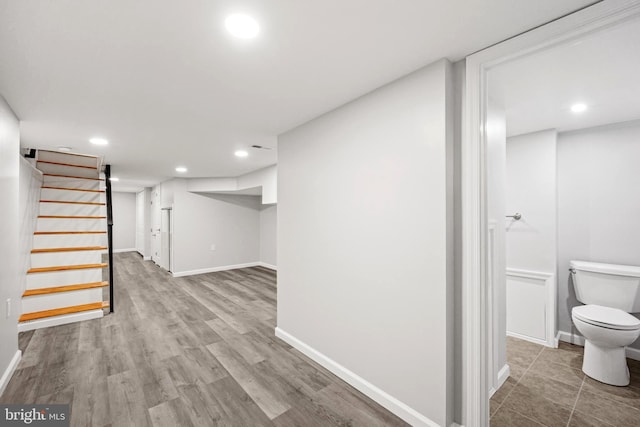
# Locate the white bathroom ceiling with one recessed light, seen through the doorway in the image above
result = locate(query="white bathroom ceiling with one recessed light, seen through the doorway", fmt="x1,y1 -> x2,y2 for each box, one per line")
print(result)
489,14 -> 640,136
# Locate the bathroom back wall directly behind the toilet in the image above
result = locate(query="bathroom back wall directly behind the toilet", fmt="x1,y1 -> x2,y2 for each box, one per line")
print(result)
558,121 -> 640,352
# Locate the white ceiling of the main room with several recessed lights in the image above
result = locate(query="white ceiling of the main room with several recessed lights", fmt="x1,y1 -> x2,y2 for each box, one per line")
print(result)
0,0 -> 594,190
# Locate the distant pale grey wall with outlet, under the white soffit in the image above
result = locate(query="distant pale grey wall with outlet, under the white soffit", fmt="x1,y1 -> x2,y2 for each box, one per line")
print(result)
172,179 -> 260,276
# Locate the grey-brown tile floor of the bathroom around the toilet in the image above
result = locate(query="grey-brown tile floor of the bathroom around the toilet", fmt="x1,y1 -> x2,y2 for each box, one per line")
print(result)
490,337 -> 640,427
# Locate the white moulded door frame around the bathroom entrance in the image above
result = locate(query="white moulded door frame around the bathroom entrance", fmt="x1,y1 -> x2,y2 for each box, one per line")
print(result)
461,0 -> 640,427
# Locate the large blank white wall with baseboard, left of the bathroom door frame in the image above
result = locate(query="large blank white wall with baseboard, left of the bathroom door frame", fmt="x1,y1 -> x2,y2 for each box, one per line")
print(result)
276,60 -> 453,425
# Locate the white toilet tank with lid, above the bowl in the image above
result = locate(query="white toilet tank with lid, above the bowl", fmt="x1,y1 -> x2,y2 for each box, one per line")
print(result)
569,261 -> 640,313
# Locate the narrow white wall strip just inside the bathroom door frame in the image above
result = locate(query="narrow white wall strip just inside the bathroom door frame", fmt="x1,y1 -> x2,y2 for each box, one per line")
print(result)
486,99 -> 507,390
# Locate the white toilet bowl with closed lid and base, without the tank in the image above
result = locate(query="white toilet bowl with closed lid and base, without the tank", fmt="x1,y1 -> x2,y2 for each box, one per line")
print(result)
571,304 -> 640,386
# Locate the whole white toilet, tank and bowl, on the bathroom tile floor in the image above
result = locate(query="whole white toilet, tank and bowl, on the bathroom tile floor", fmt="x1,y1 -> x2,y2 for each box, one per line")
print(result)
570,261 -> 640,386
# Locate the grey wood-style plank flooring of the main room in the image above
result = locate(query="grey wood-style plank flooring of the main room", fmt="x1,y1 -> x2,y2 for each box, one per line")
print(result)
0,253 -> 406,427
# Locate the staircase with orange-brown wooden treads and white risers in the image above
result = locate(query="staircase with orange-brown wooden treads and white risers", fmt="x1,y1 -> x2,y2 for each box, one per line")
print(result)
18,150 -> 109,331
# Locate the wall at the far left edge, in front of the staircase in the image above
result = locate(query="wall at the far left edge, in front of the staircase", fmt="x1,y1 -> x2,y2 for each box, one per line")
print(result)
0,96 -> 24,393
